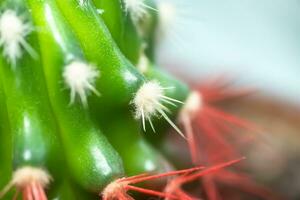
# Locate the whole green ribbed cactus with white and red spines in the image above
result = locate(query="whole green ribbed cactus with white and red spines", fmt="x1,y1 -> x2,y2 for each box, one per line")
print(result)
0,0 -> 278,200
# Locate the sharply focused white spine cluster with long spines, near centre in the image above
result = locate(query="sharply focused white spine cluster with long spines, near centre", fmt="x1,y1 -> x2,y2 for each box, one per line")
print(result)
132,81 -> 184,137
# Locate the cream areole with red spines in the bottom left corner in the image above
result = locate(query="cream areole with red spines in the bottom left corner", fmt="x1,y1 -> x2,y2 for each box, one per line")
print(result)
0,166 -> 52,200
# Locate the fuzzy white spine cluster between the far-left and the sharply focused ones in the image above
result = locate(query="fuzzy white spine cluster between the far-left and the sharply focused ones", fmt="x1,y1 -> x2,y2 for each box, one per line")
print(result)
63,61 -> 100,106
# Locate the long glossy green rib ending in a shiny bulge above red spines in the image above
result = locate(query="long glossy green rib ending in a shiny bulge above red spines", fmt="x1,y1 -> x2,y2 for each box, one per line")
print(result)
29,0 -> 123,192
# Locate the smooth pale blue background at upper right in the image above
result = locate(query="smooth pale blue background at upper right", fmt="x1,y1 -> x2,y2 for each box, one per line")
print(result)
160,0 -> 300,105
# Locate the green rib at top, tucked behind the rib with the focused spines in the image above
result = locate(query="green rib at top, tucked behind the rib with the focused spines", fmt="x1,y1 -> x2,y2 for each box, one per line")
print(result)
93,0 -> 142,65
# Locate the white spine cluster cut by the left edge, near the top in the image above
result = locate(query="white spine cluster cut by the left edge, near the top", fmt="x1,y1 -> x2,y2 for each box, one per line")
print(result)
0,10 -> 37,66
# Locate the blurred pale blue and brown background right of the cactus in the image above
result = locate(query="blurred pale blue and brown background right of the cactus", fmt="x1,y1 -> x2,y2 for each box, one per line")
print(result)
159,0 -> 300,199
